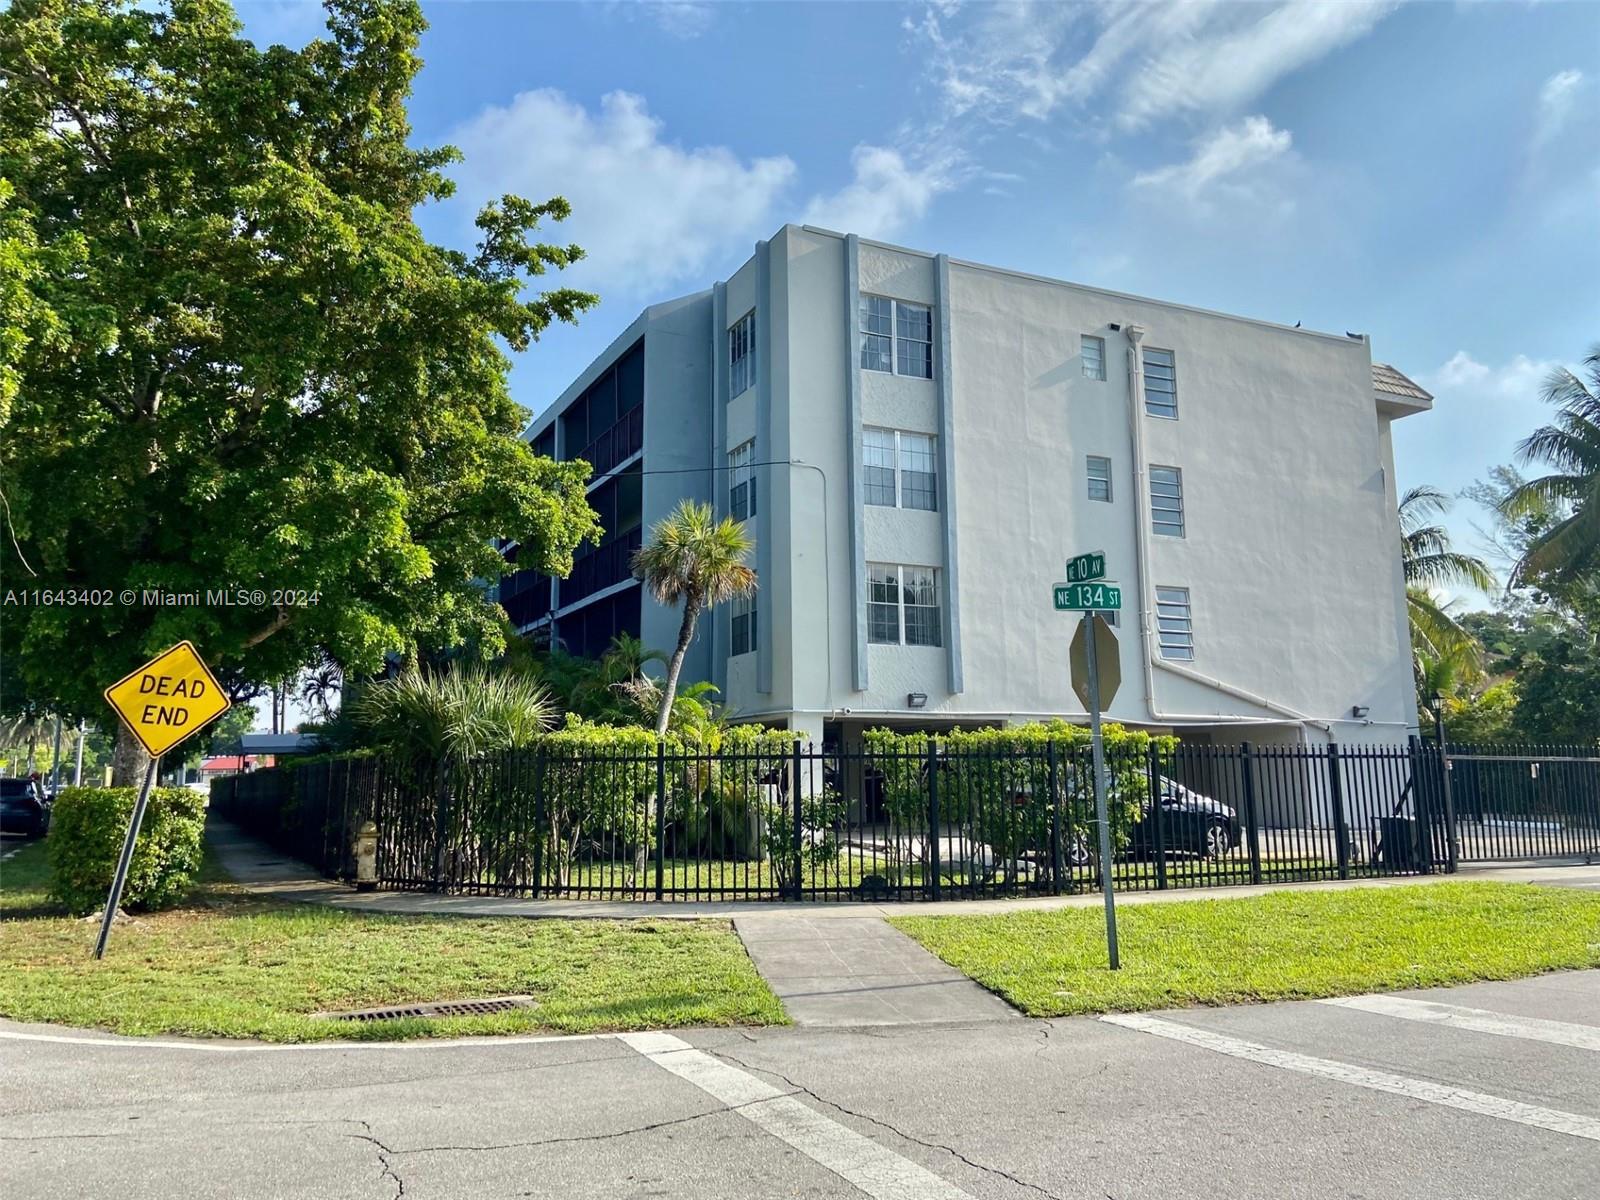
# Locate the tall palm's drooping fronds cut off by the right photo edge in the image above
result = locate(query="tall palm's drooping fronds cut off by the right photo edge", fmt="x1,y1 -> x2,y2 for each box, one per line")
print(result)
1501,342 -> 1600,590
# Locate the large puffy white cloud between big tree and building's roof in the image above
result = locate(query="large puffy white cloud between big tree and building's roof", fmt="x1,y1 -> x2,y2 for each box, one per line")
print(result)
448,88 -> 796,296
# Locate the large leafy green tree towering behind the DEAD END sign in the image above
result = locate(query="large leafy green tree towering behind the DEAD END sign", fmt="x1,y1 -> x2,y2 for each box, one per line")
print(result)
0,0 -> 597,778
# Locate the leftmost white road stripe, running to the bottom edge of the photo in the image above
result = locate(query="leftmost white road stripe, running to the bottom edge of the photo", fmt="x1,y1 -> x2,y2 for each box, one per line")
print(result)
619,1034 -> 973,1200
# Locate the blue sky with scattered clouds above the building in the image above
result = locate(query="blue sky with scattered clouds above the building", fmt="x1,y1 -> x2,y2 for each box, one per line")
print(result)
240,0 -> 1600,598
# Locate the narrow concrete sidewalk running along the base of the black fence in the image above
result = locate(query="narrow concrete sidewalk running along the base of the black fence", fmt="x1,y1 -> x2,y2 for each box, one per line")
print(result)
206,816 -> 1600,922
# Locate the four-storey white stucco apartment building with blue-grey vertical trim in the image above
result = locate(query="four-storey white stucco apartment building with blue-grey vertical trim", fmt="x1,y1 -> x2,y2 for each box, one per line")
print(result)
501,226 -> 1432,744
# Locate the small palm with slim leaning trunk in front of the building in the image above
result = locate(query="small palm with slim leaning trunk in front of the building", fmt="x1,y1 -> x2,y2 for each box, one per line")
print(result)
634,501 -> 755,736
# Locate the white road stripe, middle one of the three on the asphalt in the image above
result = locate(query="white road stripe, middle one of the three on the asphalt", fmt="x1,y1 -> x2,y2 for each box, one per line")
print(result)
1101,1013 -> 1600,1142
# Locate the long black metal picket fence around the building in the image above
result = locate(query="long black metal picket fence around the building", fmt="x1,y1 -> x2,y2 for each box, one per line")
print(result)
213,741 -> 1600,901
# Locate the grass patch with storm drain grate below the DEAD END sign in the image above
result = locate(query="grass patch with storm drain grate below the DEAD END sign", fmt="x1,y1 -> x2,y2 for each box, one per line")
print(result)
0,843 -> 786,1042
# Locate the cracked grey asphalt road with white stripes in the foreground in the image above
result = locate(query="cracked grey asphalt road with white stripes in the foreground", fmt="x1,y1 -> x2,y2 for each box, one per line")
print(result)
0,971 -> 1600,1200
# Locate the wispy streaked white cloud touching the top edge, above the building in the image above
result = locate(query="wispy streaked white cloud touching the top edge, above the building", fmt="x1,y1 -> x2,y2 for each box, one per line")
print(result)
915,0 -> 1395,130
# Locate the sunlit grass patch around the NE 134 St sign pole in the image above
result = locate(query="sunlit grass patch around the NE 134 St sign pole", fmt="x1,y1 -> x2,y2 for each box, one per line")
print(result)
891,883 -> 1600,1016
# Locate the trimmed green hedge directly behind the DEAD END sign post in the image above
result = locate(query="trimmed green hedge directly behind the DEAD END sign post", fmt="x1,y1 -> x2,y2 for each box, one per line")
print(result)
46,787 -> 205,914
